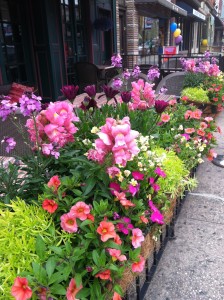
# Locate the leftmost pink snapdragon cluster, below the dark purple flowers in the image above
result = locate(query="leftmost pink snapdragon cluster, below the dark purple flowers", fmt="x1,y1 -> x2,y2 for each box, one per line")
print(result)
26,101 -> 79,158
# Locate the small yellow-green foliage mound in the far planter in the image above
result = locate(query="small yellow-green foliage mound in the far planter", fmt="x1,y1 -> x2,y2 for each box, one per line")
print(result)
181,87 -> 210,103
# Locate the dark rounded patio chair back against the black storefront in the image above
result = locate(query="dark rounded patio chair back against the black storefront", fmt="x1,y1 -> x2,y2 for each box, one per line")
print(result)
74,62 -> 104,93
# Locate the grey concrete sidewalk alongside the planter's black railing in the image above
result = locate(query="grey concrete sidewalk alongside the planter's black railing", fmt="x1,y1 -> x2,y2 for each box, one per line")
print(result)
144,112 -> 224,300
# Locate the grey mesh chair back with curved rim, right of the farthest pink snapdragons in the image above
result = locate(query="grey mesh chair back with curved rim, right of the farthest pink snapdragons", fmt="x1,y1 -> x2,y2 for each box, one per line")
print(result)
156,71 -> 186,99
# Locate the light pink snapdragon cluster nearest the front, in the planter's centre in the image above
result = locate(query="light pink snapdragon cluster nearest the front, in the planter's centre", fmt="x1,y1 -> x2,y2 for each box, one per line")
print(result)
88,117 -> 139,166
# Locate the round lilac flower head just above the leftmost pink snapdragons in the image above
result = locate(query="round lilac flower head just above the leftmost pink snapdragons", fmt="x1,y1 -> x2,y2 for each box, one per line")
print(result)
19,93 -> 42,117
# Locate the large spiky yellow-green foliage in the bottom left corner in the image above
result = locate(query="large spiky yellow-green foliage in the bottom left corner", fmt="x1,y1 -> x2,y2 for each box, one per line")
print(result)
0,198 -> 56,299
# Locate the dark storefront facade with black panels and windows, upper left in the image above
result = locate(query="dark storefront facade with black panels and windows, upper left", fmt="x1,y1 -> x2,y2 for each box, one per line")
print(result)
0,0 -> 115,101
